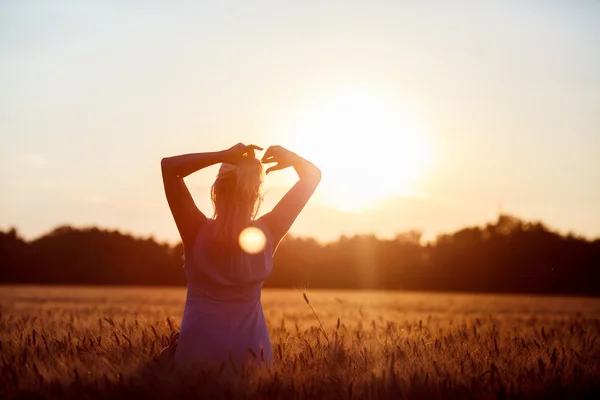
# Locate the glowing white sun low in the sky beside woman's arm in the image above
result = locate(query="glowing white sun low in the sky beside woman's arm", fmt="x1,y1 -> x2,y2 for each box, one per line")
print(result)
283,91 -> 431,211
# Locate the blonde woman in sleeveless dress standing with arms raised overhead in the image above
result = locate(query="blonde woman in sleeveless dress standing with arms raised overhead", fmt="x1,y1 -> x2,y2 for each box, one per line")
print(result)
161,143 -> 321,366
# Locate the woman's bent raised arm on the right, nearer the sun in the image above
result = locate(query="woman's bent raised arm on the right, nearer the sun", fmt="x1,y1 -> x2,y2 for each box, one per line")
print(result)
260,146 -> 321,246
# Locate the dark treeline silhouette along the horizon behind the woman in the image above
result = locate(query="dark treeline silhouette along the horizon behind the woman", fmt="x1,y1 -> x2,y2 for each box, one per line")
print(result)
0,215 -> 600,295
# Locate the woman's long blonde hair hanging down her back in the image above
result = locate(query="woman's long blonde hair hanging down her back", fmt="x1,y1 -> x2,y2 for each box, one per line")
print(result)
210,156 -> 263,251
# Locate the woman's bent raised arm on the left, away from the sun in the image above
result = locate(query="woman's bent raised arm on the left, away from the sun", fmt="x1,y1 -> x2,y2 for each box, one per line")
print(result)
161,143 -> 262,248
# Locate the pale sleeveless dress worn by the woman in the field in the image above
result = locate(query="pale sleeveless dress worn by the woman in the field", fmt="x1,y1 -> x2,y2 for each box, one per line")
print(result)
175,219 -> 274,366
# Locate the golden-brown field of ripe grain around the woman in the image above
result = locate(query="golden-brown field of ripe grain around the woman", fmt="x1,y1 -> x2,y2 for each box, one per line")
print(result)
0,286 -> 600,399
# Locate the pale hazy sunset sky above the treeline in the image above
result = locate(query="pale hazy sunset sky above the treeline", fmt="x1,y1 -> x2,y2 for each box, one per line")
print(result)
0,0 -> 600,242
